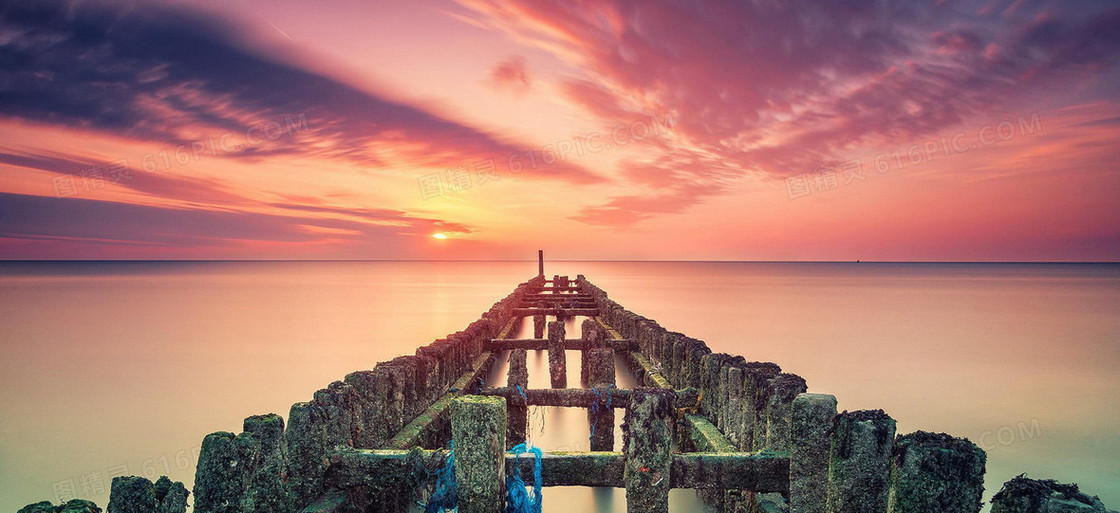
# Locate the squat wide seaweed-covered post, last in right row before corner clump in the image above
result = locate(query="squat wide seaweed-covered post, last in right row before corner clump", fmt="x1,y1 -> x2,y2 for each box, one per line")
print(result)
887,431 -> 988,513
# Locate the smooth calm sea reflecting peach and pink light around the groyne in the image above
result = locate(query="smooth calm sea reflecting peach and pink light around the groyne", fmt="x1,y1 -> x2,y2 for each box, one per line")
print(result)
0,262 -> 1120,512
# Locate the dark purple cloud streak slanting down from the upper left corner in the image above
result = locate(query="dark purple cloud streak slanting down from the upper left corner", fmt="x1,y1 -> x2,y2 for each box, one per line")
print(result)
0,0 -> 601,184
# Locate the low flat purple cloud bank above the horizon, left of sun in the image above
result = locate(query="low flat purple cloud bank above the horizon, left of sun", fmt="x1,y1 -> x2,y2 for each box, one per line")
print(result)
0,193 -> 470,258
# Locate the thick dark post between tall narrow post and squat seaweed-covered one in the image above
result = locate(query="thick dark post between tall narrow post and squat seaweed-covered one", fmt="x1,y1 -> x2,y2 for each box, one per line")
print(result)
825,410 -> 895,513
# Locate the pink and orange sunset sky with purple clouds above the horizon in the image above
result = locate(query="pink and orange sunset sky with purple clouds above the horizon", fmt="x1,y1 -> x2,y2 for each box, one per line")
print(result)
0,0 -> 1120,262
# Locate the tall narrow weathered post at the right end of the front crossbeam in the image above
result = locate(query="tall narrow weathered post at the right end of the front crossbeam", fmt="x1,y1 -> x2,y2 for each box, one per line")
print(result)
790,393 -> 837,513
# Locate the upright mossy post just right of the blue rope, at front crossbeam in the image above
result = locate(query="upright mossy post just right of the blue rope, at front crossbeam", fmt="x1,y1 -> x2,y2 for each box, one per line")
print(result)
623,388 -> 676,513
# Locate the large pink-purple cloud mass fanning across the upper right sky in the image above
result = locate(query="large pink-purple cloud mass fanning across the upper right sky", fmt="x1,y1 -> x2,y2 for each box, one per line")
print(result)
461,0 -> 1120,225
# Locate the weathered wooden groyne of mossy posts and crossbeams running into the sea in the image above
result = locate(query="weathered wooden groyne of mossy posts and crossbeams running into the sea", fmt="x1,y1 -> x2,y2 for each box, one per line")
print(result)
26,253 -> 1104,513
